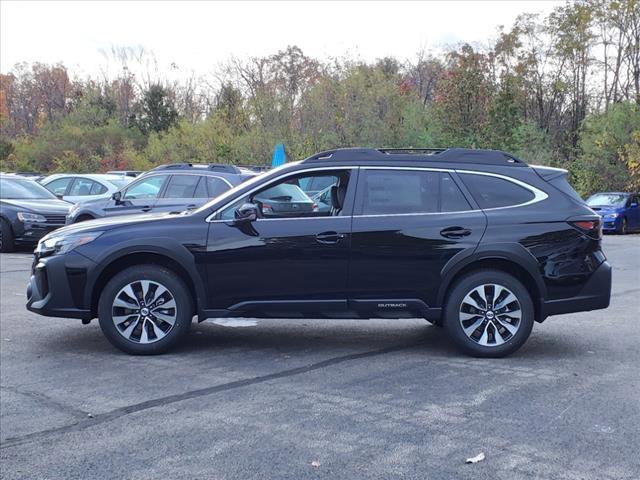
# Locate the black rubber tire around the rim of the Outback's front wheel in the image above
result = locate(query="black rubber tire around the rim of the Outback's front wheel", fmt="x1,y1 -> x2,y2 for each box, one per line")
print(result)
98,265 -> 194,355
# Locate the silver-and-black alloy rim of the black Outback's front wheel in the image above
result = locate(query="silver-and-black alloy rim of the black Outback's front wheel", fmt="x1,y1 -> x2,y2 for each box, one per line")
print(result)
111,280 -> 178,344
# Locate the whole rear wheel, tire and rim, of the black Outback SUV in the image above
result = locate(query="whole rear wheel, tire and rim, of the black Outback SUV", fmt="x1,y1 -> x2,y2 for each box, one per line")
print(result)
445,270 -> 534,357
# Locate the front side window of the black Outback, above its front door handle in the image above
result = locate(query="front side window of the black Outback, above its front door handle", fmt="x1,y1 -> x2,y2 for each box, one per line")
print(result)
221,170 -> 349,220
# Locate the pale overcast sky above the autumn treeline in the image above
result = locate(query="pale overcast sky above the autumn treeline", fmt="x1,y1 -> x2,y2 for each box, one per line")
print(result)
0,0 -> 564,76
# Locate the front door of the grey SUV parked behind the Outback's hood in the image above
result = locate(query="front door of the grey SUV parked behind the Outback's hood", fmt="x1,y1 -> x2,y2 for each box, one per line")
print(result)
104,174 -> 169,216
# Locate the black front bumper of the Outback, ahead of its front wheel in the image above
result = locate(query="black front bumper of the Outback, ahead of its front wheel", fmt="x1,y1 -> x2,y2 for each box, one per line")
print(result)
27,252 -> 95,320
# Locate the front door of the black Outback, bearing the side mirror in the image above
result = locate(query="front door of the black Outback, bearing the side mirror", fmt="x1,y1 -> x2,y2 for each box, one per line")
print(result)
206,168 -> 357,315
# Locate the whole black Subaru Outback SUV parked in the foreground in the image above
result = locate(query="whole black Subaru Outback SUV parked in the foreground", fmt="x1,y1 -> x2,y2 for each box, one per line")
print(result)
27,149 -> 611,357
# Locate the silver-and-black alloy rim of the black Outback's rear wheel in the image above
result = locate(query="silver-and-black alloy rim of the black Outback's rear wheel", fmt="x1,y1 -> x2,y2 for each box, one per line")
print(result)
459,283 -> 522,347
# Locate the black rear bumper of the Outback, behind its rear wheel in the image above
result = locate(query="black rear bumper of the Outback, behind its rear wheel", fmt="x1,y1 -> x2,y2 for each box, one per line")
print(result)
542,260 -> 611,319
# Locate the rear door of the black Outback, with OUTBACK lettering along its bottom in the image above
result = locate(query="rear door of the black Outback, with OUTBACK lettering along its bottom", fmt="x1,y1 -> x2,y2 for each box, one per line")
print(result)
349,167 -> 486,313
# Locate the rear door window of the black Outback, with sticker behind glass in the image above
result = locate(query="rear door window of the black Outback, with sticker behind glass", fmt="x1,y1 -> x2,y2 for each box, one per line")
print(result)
358,170 -> 471,215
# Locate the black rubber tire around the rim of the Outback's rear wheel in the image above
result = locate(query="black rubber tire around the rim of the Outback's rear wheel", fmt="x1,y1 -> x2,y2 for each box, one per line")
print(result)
444,270 -> 534,358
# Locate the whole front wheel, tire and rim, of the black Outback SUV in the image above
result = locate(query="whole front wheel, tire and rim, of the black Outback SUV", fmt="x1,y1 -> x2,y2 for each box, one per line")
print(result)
98,265 -> 193,355
